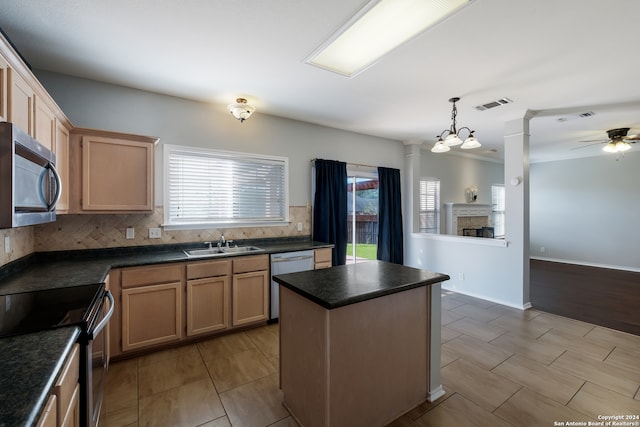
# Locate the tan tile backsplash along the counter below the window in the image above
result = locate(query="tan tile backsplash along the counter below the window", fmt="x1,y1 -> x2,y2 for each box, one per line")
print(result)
33,206 -> 311,254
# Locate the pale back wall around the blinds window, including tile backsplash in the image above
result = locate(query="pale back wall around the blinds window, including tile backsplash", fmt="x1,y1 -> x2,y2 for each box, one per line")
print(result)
0,70 -> 404,265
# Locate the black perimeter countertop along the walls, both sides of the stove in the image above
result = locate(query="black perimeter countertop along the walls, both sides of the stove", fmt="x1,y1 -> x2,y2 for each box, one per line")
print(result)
0,239 -> 333,427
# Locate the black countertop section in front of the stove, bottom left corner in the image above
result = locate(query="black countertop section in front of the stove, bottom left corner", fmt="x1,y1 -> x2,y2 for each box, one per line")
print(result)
0,326 -> 80,427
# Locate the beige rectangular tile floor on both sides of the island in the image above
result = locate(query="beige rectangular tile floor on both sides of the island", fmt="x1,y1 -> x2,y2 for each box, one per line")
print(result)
105,291 -> 640,427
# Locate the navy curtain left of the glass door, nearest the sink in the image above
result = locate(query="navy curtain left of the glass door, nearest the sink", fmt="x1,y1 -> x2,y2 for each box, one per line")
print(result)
313,159 -> 347,265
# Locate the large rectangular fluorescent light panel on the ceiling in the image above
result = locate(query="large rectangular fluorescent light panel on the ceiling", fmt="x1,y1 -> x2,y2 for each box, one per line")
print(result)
305,0 -> 471,77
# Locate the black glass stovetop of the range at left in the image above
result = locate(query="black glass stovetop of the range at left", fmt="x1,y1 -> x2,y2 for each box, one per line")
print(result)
0,284 -> 104,337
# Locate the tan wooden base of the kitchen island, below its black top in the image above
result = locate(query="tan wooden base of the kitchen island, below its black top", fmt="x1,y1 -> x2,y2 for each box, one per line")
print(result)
280,286 -> 431,427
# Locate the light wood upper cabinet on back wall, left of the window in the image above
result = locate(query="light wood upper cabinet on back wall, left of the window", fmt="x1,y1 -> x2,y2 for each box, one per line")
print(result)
70,129 -> 158,213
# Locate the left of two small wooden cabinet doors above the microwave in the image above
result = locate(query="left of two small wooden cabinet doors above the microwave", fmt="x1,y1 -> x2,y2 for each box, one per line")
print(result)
7,68 -> 35,136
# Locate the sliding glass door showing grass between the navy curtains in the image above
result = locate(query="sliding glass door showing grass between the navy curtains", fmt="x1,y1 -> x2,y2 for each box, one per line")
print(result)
347,172 -> 378,264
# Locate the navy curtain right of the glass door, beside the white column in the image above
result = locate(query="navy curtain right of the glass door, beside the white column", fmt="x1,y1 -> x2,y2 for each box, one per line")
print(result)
377,167 -> 404,264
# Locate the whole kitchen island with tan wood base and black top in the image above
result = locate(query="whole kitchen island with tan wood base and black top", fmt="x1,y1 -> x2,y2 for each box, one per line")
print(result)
274,261 -> 449,427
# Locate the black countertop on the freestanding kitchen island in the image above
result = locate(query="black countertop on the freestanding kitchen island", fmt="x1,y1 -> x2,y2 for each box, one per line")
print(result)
273,261 -> 450,310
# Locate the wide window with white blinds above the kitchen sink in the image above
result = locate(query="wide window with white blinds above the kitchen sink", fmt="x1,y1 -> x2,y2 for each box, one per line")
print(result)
164,145 -> 289,226
